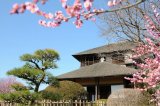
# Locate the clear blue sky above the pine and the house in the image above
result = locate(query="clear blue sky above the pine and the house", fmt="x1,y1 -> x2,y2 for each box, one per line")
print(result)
0,0 -> 107,89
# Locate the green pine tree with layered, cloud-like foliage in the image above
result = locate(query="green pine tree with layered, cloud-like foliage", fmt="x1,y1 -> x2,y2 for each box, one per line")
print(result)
7,49 -> 59,92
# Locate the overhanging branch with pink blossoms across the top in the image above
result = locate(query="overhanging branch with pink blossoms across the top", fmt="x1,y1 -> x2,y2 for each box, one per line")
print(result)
10,0 -> 146,28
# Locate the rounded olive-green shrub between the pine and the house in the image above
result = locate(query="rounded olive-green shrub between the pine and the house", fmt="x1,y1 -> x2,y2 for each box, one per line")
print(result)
44,81 -> 86,100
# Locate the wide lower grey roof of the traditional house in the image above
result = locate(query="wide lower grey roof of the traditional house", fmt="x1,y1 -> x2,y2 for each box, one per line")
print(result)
57,62 -> 137,79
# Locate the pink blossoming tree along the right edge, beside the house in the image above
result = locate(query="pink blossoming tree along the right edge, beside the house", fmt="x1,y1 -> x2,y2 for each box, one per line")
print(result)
126,2 -> 160,106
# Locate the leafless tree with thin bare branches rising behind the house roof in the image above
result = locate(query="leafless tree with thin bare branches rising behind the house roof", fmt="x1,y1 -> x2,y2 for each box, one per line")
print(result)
98,0 -> 160,42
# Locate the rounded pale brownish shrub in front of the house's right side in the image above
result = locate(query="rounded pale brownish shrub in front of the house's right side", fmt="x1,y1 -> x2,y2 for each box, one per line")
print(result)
107,89 -> 155,106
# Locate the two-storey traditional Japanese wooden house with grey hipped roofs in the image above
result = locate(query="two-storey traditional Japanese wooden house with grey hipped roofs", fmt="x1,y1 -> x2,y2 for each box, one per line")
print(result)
58,42 -> 136,100
